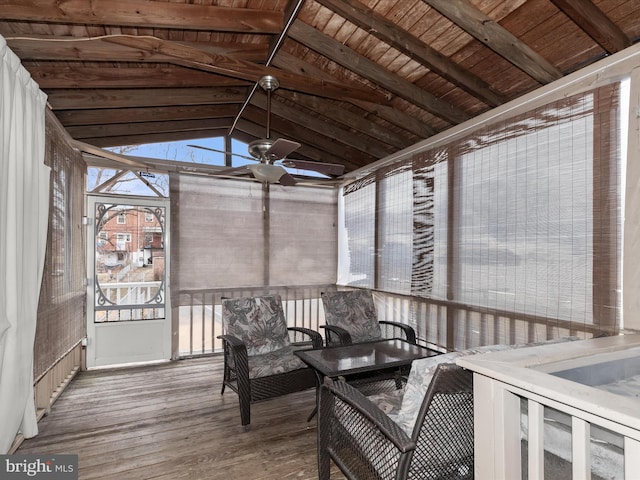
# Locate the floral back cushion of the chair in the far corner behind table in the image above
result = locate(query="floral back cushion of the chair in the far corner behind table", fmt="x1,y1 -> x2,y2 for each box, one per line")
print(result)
322,290 -> 382,343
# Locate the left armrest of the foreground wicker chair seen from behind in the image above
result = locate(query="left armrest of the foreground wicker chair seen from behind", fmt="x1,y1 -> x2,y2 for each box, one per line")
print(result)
318,377 -> 416,453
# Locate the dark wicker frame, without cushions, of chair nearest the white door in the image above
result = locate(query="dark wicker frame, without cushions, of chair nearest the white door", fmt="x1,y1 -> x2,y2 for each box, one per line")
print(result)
218,327 -> 323,429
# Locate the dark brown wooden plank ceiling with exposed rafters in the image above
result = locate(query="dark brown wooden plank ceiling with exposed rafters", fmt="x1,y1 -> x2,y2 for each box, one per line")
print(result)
0,0 -> 640,175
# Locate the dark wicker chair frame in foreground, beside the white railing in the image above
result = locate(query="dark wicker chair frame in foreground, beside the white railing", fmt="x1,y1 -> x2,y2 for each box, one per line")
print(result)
318,363 -> 474,480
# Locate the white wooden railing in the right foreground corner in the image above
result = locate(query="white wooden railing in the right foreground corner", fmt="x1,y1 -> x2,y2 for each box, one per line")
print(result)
456,334 -> 640,480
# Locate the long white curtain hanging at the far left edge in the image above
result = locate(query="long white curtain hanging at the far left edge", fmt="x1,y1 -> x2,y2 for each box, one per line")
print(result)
0,36 -> 49,454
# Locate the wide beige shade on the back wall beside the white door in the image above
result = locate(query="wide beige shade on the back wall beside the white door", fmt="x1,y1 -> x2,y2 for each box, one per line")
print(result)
170,174 -> 337,292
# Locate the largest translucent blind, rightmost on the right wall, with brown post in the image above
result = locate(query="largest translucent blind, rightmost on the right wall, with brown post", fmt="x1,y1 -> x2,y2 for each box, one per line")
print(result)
450,85 -> 620,325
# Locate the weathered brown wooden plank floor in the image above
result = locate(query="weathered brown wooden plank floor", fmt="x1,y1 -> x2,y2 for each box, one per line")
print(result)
16,357 -> 344,480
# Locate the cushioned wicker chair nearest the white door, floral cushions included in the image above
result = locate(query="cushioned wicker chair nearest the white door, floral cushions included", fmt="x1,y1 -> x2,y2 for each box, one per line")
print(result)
218,295 -> 322,429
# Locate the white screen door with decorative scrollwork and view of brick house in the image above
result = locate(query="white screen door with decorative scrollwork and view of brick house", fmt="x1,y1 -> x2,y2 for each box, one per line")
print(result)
86,196 -> 171,368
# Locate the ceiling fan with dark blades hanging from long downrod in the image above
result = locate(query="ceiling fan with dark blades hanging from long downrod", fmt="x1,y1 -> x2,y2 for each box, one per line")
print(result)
189,75 -> 344,186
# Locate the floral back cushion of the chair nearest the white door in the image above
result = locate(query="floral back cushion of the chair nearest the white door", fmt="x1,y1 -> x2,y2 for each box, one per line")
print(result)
222,295 -> 290,357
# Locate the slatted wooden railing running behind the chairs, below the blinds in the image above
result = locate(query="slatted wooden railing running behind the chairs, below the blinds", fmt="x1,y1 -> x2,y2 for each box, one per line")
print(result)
173,285 -> 601,356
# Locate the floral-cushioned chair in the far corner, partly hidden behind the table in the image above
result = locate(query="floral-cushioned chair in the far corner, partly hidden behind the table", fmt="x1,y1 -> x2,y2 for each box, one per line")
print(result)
321,290 -> 416,347
